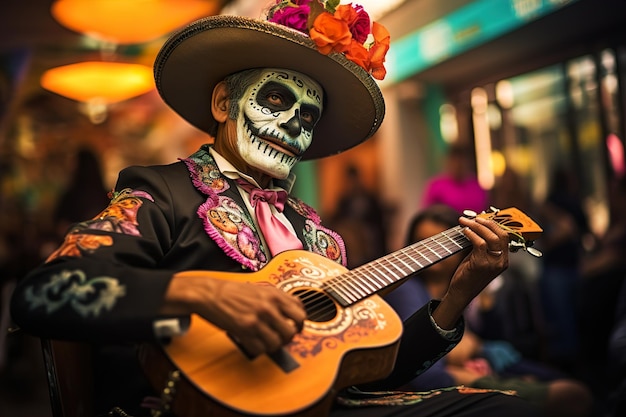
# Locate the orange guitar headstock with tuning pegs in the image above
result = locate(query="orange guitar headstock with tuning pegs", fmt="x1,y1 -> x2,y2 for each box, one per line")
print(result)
477,207 -> 543,257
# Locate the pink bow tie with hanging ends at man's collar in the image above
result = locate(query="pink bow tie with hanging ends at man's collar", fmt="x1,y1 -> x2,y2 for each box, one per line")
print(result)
237,179 -> 302,256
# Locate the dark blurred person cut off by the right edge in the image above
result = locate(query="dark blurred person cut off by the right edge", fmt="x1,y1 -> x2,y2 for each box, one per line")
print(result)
578,177 -> 626,417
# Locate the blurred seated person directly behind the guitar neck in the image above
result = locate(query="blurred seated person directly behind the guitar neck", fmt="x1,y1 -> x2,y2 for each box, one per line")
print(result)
385,204 -> 592,417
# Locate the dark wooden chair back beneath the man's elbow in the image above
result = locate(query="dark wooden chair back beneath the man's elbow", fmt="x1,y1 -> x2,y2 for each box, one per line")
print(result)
41,339 -> 94,417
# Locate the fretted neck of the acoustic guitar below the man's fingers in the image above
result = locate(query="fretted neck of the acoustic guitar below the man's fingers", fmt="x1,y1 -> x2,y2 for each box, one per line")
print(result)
324,226 -> 471,307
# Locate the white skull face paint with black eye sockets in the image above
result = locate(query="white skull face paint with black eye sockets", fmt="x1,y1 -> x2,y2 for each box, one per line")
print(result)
237,69 -> 323,179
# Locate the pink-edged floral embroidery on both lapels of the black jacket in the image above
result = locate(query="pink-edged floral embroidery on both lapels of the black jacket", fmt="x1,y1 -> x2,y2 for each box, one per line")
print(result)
182,145 -> 346,271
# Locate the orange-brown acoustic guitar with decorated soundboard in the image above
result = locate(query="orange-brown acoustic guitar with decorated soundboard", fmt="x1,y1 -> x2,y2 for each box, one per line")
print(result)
140,208 -> 542,417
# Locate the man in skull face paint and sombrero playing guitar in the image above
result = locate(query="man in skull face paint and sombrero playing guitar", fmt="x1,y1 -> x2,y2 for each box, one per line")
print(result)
11,0 -> 535,417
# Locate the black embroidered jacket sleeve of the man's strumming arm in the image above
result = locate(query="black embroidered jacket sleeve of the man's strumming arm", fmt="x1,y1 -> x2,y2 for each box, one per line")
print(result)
11,167 -> 188,343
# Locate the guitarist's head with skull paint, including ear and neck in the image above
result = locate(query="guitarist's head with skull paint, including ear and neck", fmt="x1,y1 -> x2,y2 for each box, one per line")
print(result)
213,69 -> 323,183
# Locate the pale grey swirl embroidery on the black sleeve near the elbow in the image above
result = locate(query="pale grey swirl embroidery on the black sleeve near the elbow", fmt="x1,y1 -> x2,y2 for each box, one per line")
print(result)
26,270 -> 126,317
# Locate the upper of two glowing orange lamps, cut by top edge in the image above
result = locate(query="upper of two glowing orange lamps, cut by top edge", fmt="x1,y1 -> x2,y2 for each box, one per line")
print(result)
51,0 -> 219,44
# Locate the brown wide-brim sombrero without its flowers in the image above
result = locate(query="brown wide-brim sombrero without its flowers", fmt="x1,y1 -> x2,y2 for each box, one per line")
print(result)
154,16 -> 385,160
